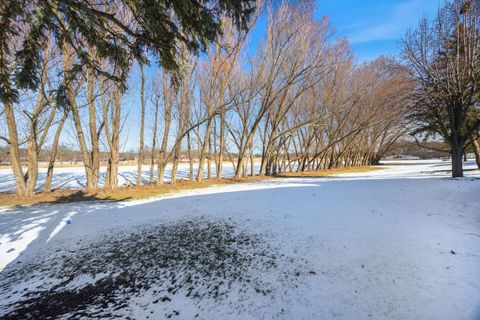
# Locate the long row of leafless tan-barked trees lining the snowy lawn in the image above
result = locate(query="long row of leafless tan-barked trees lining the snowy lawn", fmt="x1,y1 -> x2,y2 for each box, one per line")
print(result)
1,1 -> 412,195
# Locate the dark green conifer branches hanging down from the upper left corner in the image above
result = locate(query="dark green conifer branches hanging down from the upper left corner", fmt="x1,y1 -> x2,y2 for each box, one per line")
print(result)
0,0 -> 256,103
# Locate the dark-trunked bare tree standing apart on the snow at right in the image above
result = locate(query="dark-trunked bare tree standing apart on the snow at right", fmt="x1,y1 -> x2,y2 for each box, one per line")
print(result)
403,0 -> 480,177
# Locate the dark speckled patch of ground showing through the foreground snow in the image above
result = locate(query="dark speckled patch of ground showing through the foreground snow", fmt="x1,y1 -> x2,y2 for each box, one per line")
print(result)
0,218 -> 306,319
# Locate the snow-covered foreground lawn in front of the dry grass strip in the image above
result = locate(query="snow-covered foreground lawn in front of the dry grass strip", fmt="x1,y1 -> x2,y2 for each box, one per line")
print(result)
0,161 -> 480,320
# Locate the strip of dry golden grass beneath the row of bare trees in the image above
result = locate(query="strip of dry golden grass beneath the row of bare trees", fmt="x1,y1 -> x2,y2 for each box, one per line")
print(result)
0,167 -> 383,207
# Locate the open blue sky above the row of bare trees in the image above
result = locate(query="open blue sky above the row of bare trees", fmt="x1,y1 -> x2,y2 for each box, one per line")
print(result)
249,0 -> 441,62
